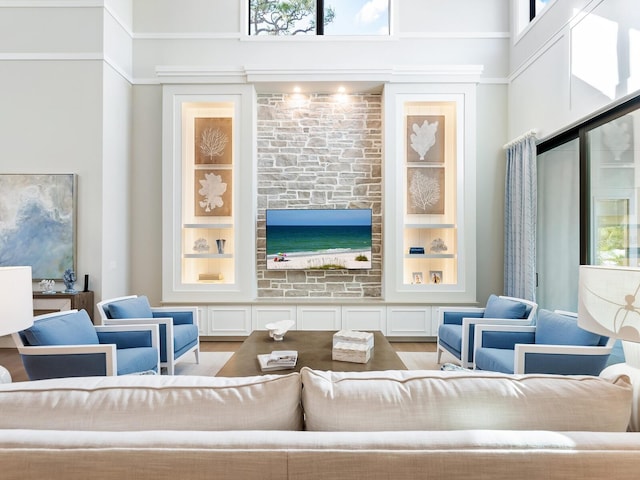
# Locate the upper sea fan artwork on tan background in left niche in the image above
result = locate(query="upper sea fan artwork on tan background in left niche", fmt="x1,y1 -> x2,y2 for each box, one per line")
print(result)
194,117 -> 233,165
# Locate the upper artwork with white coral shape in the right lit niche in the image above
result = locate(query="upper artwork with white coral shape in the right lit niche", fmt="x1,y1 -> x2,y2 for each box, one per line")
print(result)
406,115 -> 445,163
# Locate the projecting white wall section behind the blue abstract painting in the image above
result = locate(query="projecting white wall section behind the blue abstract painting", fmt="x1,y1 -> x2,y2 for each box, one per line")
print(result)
0,0 -> 132,310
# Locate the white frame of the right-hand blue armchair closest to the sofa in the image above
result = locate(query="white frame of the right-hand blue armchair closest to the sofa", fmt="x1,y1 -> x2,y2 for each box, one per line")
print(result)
473,318 -> 616,374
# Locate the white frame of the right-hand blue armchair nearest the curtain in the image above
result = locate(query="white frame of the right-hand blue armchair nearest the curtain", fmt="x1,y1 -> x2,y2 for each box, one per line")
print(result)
436,295 -> 538,368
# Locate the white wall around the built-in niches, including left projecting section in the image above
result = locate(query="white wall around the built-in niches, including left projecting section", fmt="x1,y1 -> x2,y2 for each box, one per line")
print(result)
0,0 -> 510,303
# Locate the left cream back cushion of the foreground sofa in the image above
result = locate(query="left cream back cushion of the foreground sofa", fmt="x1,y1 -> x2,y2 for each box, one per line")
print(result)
0,373 -> 303,431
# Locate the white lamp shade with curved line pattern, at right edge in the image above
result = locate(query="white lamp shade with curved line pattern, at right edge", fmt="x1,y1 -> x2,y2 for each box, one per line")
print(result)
578,265 -> 640,342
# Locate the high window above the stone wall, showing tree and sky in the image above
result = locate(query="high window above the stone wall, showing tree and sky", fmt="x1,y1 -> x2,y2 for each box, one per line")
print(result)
249,0 -> 390,36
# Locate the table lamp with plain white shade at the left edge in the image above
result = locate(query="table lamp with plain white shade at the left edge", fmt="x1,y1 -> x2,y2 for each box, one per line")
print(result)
0,267 -> 33,383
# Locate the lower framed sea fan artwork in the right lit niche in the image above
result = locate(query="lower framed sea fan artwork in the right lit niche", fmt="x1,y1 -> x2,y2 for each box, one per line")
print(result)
407,167 -> 444,215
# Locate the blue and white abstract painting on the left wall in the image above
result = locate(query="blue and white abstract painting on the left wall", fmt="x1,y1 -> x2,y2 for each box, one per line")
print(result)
0,174 -> 77,280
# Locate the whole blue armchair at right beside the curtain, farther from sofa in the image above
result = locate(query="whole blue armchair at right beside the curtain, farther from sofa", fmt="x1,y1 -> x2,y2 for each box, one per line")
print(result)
437,295 -> 538,368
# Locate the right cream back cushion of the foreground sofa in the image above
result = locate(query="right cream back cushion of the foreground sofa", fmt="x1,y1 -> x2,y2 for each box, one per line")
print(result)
300,367 -> 632,432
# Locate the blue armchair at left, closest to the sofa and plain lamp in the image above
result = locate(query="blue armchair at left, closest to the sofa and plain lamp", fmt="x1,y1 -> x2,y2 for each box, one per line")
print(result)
13,310 -> 160,380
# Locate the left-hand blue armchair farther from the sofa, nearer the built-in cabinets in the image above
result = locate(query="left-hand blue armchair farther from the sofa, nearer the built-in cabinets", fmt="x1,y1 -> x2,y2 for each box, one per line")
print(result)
98,295 -> 200,375
